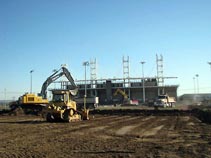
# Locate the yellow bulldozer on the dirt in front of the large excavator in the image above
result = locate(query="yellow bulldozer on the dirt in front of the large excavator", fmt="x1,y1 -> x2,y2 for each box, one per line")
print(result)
43,90 -> 89,122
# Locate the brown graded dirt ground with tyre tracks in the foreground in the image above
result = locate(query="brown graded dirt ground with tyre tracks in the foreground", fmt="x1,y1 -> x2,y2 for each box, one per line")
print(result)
0,110 -> 211,158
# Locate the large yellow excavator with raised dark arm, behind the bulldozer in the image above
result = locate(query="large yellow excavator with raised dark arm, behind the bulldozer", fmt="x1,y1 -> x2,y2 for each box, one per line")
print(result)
10,66 -> 77,114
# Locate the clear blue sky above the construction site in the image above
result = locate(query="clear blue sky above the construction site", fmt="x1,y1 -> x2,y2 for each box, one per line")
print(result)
0,0 -> 211,100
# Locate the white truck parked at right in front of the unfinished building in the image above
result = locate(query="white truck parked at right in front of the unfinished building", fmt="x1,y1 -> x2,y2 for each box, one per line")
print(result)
154,94 -> 176,108
